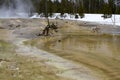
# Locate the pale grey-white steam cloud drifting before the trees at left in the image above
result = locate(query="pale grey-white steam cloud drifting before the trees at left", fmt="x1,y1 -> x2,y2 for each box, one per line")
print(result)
0,0 -> 34,18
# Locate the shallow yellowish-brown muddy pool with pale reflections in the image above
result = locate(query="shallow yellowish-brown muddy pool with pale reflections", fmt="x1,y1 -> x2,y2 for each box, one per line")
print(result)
44,35 -> 120,80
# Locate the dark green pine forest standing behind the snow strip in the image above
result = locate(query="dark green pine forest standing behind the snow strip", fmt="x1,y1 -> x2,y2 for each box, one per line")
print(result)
30,0 -> 120,16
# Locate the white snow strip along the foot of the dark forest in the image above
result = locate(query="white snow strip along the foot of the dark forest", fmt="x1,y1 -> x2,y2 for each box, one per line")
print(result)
31,13 -> 120,25
